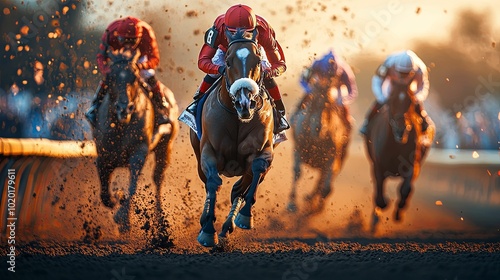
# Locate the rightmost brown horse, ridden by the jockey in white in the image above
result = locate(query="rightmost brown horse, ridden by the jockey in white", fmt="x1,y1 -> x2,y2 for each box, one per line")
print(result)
365,82 -> 435,230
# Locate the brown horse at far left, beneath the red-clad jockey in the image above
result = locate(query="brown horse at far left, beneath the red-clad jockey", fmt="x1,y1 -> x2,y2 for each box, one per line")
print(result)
93,51 -> 179,232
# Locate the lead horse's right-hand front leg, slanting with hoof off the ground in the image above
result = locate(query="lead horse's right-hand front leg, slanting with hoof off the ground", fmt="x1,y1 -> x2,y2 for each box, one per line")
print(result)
235,157 -> 270,229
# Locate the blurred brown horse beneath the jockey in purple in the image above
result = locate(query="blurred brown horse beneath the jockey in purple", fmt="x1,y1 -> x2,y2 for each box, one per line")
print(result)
288,83 -> 352,214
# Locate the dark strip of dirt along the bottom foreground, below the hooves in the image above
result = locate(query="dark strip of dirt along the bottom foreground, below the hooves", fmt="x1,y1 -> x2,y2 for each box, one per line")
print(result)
0,239 -> 500,280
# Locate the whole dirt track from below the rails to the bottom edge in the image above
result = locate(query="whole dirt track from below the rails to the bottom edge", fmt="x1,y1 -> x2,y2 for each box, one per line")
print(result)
0,127 -> 500,280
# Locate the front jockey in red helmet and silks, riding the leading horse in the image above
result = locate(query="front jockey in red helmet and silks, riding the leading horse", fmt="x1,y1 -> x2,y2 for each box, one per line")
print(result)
187,4 -> 290,135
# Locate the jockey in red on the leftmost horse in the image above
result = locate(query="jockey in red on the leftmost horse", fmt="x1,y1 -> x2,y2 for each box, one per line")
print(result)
85,16 -> 168,126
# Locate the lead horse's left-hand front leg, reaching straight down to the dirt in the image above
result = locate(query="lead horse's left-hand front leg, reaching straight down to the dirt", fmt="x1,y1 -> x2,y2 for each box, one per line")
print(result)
197,148 -> 222,247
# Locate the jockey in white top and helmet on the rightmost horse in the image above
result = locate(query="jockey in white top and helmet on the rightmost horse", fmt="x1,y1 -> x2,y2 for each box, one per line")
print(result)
360,50 -> 430,145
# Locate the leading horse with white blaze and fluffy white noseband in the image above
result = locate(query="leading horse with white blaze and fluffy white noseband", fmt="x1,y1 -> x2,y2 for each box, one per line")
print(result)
190,31 -> 274,247
